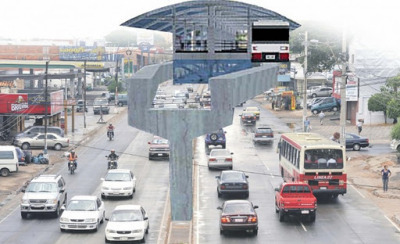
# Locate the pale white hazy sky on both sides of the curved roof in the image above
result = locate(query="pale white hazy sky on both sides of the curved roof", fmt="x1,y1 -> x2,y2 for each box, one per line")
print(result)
0,0 -> 400,49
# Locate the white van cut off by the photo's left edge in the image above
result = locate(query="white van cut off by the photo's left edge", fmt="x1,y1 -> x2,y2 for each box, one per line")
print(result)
0,146 -> 18,177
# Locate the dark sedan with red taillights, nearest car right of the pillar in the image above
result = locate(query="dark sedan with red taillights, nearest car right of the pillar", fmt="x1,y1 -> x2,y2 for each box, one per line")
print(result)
217,200 -> 258,235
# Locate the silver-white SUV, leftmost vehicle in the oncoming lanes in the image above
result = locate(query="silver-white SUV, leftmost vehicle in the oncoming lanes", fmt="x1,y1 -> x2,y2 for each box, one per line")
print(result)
20,175 -> 67,219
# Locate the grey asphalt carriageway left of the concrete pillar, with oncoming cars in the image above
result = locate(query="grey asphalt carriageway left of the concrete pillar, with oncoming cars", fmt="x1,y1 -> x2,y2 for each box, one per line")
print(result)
0,116 -> 169,244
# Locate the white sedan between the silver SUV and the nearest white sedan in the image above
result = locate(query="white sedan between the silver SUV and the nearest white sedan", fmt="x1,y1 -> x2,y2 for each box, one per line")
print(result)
60,196 -> 105,232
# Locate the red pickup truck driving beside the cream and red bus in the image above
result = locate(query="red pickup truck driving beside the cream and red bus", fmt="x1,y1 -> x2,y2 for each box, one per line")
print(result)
275,182 -> 317,222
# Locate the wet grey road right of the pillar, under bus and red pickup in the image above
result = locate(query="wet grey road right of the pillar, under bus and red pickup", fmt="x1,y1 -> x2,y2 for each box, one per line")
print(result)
194,102 -> 400,244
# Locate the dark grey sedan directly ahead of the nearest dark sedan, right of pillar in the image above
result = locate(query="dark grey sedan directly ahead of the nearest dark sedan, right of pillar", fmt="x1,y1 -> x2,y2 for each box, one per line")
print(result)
215,170 -> 249,198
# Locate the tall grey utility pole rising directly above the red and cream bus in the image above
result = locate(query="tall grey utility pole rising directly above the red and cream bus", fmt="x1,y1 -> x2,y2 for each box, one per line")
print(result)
340,31 -> 347,146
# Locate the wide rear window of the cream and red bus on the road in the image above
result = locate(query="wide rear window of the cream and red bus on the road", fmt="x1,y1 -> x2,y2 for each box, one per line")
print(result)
304,149 -> 343,169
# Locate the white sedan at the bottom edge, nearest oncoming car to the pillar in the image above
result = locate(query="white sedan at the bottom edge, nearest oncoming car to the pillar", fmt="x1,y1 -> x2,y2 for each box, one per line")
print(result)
105,205 -> 149,243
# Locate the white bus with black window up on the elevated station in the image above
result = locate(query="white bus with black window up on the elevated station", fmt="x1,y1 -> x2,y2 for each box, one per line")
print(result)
251,20 -> 290,62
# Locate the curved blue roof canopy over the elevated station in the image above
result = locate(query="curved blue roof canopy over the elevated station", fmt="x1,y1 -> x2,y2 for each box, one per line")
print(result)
121,0 -> 300,35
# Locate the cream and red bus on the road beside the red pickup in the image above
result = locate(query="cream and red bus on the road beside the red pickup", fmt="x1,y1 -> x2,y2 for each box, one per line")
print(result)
278,133 -> 347,198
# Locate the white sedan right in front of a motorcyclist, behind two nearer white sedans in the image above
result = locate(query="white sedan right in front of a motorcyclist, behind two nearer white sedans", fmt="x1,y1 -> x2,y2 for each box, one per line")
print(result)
101,169 -> 136,198
